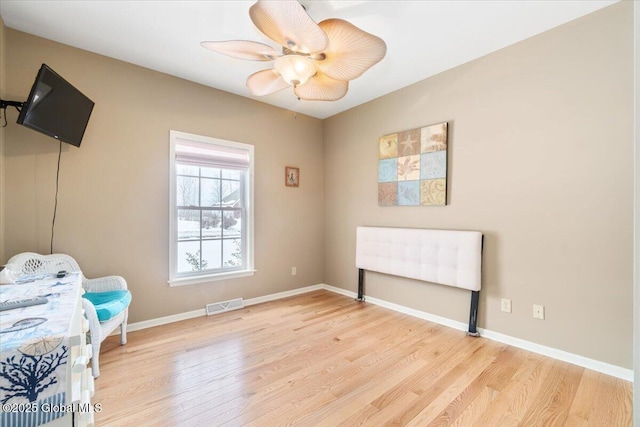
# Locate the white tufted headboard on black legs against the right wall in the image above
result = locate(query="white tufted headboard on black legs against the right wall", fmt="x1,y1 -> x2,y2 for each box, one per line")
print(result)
356,227 -> 482,335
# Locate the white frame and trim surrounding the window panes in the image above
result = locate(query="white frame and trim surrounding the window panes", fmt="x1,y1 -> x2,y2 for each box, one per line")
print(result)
168,130 -> 255,286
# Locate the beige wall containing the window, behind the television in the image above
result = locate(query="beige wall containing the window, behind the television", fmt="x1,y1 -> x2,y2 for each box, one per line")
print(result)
2,29 -> 324,322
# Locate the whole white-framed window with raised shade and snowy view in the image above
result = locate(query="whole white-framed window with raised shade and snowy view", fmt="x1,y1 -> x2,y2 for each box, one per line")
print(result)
169,131 -> 253,286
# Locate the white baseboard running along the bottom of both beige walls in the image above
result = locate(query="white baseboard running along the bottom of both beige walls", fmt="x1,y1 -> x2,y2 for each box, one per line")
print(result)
127,283 -> 633,382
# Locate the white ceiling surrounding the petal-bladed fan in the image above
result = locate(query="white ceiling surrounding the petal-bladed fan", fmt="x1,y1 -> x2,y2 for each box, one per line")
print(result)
0,0 -> 617,119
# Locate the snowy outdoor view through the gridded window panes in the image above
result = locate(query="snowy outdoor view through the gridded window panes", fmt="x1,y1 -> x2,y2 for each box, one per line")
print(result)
176,164 -> 245,273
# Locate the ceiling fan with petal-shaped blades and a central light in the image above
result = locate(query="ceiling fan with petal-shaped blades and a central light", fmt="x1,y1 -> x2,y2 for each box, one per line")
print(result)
200,0 -> 387,101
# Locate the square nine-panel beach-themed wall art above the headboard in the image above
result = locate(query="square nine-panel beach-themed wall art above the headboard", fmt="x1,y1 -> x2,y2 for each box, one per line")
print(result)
378,122 -> 448,206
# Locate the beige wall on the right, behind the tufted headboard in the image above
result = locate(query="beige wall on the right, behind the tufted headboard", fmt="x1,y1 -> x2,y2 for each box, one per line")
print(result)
324,2 -> 633,368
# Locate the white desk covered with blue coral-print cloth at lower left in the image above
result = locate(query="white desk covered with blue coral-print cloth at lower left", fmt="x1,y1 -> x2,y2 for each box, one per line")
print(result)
0,273 -> 93,427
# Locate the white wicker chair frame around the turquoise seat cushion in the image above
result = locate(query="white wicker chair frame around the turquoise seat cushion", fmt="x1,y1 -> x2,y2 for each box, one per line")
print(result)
7,252 -> 129,378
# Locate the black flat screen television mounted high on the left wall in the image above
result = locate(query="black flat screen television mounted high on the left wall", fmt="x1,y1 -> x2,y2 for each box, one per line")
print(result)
18,64 -> 94,147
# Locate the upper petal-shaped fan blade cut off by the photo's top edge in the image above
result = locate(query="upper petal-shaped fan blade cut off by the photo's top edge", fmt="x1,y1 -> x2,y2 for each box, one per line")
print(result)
249,0 -> 329,53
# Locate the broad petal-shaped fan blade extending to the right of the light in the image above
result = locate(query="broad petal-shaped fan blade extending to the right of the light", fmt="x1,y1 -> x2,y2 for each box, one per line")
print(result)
317,19 -> 387,80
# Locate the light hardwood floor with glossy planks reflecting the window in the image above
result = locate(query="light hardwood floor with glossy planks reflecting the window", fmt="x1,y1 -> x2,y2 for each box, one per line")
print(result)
93,291 -> 632,427
